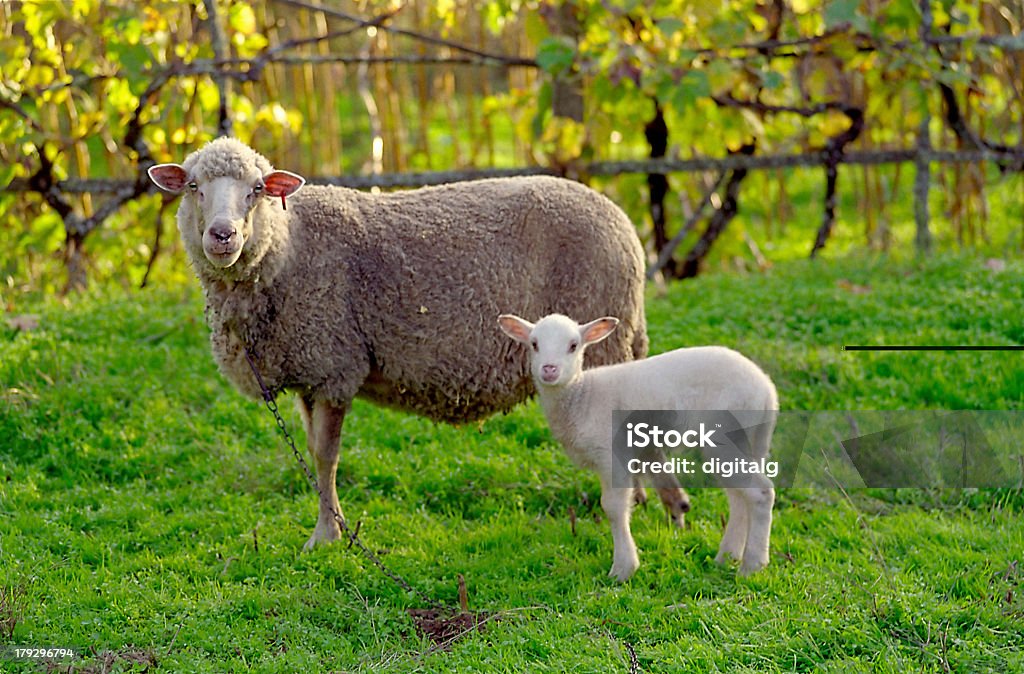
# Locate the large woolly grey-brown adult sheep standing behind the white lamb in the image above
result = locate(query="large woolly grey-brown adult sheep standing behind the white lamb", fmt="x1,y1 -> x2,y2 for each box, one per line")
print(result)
150,138 -> 651,548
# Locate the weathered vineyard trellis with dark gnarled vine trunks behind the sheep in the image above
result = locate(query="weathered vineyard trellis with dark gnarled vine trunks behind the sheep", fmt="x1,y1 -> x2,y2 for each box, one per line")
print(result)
0,0 -> 1024,286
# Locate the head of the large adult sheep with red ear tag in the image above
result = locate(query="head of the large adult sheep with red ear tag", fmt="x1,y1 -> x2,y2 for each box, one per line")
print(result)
148,138 -> 305,269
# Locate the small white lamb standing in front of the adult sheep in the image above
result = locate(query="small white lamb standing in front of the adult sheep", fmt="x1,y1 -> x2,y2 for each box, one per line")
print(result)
498,314 -> 778,581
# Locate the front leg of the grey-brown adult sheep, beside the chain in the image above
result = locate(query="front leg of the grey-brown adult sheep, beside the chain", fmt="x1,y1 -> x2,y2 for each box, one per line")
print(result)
299,398 -> 345,550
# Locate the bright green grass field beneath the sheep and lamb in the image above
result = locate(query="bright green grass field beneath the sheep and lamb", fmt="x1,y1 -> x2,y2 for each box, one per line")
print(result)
0,257 -> 1024,672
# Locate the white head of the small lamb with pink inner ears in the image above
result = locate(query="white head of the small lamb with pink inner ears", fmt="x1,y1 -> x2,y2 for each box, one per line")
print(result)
498,313 -> 618,388
